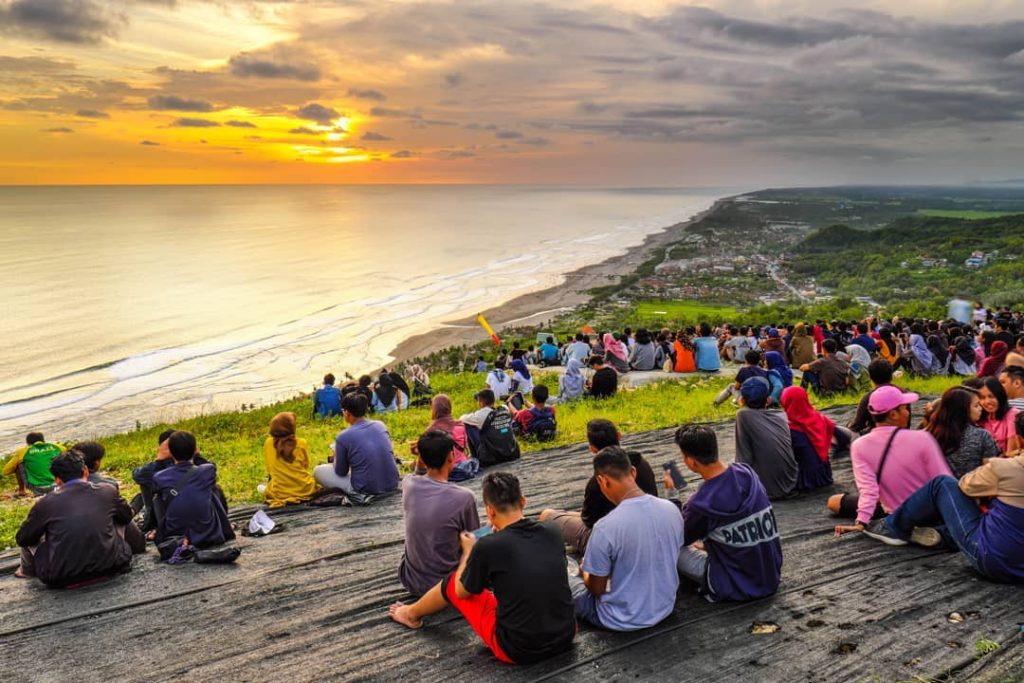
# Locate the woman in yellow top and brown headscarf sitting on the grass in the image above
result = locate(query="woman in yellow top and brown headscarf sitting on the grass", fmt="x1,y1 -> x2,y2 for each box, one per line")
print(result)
263,413 -> 318,508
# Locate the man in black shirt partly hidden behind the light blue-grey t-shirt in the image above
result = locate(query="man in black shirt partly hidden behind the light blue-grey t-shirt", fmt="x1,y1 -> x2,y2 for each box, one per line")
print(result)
541,419 -> 657,556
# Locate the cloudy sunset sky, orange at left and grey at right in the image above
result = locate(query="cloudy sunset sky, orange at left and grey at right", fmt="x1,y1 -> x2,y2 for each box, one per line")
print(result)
0,0 -> 1024,186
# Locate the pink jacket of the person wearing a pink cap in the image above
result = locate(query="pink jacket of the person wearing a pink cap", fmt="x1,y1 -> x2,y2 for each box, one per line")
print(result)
850,426 -> 953,524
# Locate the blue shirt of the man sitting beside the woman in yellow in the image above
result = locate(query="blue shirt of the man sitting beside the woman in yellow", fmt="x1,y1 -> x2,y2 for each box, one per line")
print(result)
334,420 -> 398,496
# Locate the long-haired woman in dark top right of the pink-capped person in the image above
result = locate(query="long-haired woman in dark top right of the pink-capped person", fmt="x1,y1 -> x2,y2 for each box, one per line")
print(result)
926,387 -> 1000,479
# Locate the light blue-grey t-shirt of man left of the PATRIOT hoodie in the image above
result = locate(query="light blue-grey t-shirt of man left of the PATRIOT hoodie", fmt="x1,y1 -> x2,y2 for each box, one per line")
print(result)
583,494 -> 683,631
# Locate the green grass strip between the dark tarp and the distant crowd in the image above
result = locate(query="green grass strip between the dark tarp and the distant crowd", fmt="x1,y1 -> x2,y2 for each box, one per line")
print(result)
0,373 -> 956,548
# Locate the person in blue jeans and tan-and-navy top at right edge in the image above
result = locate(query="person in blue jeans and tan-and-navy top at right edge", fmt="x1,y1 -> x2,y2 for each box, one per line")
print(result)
864,414 -> 1024,584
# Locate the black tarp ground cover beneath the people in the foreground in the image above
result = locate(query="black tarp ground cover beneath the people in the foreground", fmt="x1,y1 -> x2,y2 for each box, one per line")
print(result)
0,403 -> 1024,683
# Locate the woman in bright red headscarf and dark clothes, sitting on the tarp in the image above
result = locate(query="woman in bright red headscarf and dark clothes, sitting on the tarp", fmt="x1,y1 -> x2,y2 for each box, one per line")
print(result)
782,386 -> 835,490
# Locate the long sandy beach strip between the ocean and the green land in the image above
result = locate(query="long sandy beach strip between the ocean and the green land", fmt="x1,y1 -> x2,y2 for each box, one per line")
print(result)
388,196 -> 735,365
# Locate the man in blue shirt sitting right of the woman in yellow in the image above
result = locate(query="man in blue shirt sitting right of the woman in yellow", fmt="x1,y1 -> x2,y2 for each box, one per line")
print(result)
313,393 -> 398,496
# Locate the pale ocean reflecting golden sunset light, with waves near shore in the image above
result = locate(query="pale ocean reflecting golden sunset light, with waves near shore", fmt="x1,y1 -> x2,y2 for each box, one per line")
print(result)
0,185 -> 724,452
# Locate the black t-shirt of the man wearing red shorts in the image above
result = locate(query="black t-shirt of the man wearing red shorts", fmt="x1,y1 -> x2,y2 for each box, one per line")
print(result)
462,519 -> 577,664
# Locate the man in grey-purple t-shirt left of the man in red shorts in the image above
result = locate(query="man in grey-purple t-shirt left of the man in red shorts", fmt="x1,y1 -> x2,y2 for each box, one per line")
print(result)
398,429 -> 480,596
